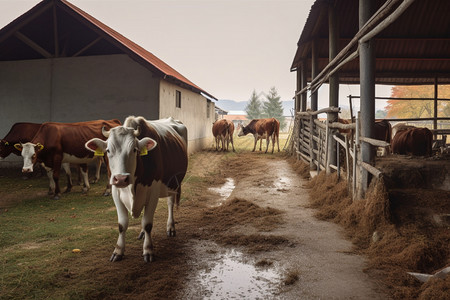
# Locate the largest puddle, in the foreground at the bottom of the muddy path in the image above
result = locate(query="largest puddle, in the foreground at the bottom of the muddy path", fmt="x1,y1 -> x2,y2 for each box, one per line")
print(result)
197,250 -> 281,299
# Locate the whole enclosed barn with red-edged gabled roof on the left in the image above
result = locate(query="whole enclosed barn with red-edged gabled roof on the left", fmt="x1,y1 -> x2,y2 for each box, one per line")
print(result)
0,0 -> 217,161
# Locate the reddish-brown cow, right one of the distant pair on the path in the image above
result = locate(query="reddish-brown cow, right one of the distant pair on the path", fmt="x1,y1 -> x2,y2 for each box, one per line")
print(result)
238,118 -> 280,153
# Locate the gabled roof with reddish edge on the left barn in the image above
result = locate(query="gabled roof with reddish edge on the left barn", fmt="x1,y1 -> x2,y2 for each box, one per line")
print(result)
0,0 -> 217,100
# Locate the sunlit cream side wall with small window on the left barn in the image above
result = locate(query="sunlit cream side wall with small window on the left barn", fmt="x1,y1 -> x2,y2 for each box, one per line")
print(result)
159,80 -> 214,153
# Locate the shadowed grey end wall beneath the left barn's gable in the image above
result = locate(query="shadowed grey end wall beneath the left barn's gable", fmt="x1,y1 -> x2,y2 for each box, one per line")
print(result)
0,55 -> 160,160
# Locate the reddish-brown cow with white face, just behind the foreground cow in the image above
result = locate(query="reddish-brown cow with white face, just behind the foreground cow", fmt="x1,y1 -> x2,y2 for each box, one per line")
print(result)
14,120 -> 120,200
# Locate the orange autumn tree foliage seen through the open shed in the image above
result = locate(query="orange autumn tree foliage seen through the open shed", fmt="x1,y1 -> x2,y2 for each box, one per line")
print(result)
386,85 -> 450,118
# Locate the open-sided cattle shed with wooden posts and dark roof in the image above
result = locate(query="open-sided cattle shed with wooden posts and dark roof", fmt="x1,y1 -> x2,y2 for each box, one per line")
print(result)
291,0 -> 450,194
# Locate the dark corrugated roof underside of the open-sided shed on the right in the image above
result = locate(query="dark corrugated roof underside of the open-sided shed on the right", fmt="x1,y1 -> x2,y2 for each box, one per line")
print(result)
291,0 -> 450,84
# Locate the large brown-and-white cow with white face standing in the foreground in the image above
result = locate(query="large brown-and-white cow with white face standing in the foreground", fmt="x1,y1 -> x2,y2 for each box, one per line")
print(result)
85,116 -> 188,262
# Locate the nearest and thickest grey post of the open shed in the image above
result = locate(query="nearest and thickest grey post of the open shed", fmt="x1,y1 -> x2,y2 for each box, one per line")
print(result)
358,0 -> 375,197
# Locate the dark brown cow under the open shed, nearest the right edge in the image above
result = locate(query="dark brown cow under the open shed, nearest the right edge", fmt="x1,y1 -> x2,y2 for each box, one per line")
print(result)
392,128 -> 433,156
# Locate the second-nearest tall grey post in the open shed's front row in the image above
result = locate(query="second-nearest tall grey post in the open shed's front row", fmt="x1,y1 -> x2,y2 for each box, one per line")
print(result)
327,5 -> 339,173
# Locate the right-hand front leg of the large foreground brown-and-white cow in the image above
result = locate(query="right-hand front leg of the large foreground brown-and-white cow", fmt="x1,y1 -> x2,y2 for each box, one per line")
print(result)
142,184 -> 160,262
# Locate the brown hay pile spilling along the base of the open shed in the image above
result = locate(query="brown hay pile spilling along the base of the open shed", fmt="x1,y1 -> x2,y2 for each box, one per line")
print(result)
295,159 -> 450,299
